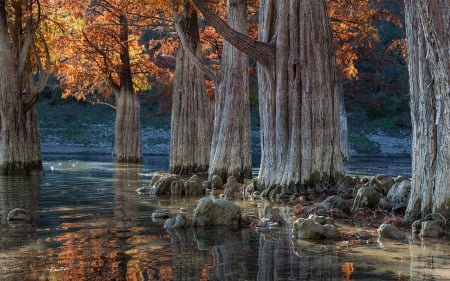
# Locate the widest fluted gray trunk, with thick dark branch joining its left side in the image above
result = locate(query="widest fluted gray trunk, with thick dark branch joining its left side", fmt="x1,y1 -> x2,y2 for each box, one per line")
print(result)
258,0 -> 343,193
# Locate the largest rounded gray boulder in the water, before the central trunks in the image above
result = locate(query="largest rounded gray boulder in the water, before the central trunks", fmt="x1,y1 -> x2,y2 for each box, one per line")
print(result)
192,197 -> 241,227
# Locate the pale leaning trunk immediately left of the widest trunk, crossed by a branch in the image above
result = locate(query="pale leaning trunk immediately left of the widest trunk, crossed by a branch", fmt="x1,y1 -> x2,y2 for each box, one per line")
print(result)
209,0 -> 252,182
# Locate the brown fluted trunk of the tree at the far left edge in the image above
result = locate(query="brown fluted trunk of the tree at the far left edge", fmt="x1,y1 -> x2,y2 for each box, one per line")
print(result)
0,3 -> 42,175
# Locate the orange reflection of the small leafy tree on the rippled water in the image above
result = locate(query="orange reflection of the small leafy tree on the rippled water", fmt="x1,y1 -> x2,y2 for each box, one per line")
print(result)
31,164 -> 176,281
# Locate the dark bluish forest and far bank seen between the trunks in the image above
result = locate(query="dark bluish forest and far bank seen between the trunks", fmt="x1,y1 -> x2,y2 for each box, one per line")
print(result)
38,0 -> 411,158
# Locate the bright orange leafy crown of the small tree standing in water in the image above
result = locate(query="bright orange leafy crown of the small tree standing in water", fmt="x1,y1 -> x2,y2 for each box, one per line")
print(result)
48,0 -> 174,99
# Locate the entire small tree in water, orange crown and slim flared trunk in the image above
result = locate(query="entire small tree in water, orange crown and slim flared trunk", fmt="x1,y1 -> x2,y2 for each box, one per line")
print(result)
52,0 -> 170,162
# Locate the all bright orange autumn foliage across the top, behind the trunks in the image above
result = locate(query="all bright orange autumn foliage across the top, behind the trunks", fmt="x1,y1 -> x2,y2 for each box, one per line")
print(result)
43,0 -> 401,103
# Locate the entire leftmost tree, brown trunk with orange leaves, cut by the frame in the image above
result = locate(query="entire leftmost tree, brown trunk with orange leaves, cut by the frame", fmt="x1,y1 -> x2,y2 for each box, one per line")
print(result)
0,1 -> 50,175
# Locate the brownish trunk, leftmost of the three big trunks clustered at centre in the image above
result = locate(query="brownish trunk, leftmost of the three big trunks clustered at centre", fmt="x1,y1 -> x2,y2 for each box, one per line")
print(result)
169,7 -> 214,175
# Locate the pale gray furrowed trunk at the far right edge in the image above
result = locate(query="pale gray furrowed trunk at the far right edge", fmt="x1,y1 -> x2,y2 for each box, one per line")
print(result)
405,0 -> 450,220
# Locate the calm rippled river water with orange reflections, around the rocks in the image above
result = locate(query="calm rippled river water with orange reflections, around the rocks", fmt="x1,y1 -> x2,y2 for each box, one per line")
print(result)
0,155 -> 450,281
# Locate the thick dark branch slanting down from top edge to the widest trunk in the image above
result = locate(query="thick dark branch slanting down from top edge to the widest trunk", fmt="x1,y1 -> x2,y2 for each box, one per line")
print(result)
189,0 -> 275,69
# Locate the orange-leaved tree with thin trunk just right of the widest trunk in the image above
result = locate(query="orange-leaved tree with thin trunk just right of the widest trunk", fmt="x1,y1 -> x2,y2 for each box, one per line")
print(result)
327,0 -> 404,158
